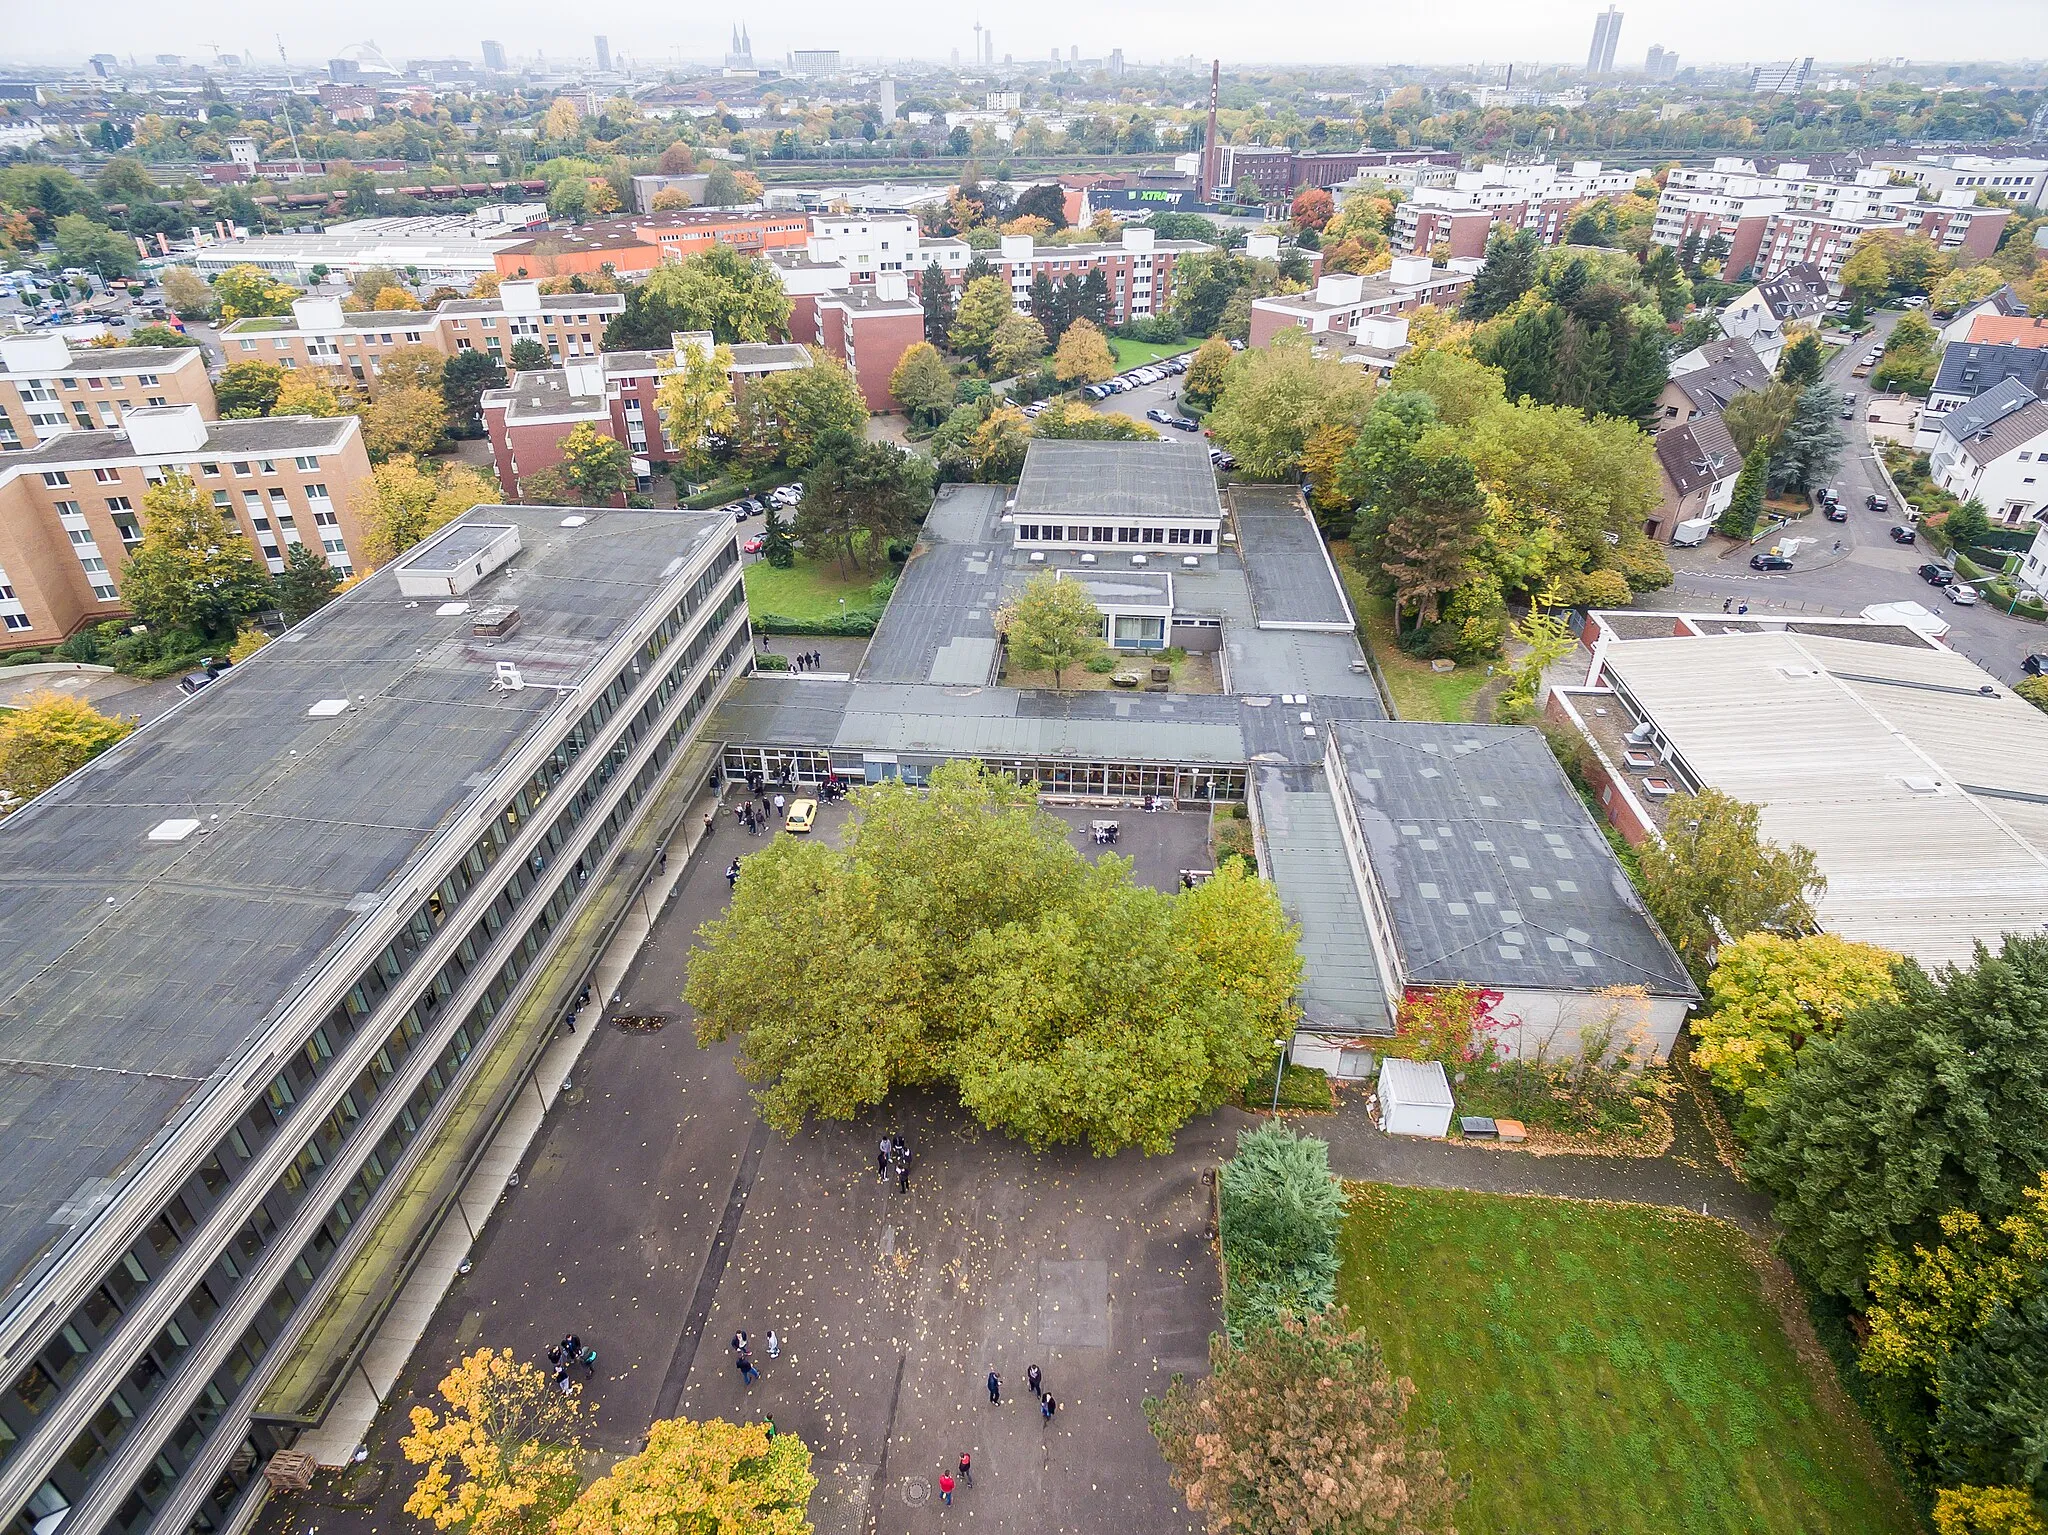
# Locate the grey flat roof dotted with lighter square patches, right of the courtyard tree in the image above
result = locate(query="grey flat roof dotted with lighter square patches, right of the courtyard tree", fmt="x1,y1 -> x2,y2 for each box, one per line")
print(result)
1335,720 -> 1698,997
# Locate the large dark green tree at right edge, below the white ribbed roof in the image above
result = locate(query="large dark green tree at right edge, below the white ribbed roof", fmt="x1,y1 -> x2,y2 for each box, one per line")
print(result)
1747,935 -> 2048,1300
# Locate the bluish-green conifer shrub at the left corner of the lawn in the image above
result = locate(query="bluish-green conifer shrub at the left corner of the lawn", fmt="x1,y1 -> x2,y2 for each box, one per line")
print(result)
1219,1124 -> 1343,1339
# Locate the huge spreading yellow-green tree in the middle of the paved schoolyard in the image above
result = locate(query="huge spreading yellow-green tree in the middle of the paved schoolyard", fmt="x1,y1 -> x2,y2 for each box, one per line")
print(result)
684,761 -> 1300,1154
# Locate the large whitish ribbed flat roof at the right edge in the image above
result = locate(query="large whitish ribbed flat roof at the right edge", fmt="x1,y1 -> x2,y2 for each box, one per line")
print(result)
1604,632 -> 2048,964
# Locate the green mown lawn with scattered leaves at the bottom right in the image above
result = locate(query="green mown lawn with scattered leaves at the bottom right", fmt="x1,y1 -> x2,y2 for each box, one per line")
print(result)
1337,1183 -> 1919,1535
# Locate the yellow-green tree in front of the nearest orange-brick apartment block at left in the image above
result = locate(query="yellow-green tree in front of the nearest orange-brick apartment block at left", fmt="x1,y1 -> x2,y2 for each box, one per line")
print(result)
121,475 -> 270,645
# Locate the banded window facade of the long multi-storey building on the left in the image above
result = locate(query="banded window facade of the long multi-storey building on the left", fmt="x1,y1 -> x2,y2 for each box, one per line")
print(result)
0,560 -> 750,1535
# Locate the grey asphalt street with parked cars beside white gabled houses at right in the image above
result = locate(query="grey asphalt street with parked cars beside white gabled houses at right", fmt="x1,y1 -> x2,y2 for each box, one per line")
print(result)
1651,313 -> 2048,682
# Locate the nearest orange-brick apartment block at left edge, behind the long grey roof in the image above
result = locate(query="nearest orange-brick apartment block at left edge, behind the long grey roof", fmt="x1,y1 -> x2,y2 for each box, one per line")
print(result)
0,405 -> 371,651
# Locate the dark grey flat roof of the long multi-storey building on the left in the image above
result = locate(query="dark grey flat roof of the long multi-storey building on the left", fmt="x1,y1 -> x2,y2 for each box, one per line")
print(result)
0,505 -> 731,1296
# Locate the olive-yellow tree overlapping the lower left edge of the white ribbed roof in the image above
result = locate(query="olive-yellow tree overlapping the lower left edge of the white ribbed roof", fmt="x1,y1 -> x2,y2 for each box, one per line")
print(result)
1640,788 -> 1827,982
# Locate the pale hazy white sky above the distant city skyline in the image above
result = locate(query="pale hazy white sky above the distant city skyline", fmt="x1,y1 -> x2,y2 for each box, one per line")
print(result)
12,0 -> 2048,68
